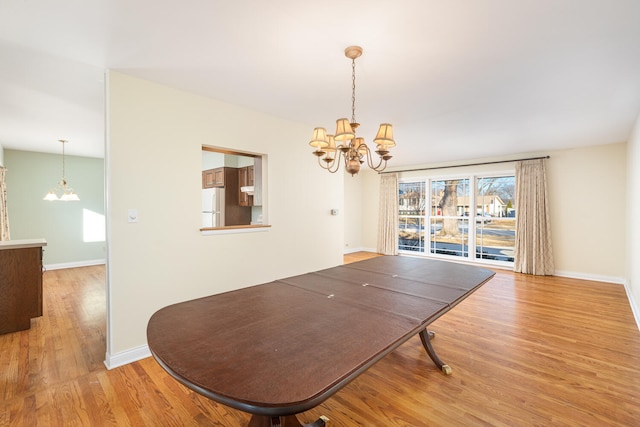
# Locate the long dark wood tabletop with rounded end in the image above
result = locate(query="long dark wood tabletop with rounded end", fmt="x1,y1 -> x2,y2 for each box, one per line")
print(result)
147,256 -> 495,425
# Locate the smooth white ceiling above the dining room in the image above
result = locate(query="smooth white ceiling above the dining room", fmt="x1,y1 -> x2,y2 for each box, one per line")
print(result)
0,0 -> 640,166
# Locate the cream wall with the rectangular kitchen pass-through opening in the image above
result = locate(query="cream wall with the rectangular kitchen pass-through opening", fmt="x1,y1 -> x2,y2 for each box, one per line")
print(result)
106,72 -> 344,364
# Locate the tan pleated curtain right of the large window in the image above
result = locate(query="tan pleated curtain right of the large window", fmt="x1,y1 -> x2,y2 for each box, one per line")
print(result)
513,159 -> 554,275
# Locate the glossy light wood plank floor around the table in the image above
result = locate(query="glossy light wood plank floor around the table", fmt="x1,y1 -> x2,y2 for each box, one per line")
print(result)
0,254 -> 640,427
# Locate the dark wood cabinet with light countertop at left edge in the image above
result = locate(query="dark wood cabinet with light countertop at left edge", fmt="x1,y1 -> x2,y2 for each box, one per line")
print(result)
0,241 -> 46,334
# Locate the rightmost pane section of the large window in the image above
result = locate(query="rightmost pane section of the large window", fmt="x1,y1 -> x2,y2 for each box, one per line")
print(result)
476,176 -> 516,262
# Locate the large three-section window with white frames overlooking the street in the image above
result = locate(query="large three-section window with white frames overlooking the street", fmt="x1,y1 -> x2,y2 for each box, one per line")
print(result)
398,174 -> 516,265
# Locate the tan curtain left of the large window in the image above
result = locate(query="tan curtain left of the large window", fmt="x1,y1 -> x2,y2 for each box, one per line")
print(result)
378,173 -> 398,255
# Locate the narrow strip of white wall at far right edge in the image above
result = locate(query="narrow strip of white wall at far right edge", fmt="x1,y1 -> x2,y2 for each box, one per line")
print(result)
626,115 -> 640,325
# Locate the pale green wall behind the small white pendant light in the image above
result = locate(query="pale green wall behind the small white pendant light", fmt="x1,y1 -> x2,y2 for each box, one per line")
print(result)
4,149 -> 107,268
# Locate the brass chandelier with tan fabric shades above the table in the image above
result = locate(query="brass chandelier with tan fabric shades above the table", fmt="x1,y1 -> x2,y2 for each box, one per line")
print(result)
309,46 -> 396,176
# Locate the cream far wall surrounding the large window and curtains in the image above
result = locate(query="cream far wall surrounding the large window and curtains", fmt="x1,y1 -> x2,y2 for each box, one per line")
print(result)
347,143 -> 627,283
